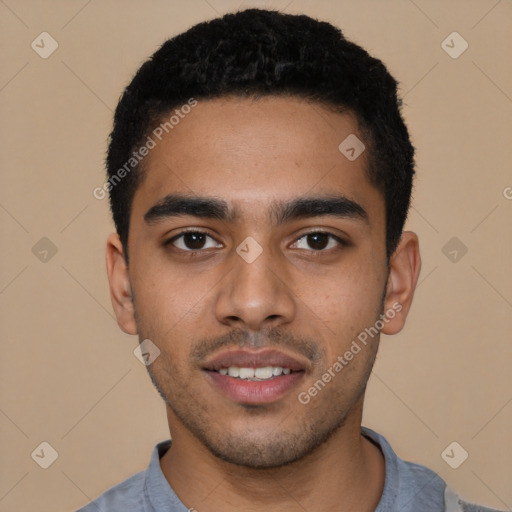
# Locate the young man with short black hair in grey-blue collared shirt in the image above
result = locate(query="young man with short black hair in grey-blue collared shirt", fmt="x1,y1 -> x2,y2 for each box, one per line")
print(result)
82,10 -> 500,512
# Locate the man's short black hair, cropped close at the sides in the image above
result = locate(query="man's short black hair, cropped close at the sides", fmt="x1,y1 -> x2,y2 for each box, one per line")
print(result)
106,9 -> 414,261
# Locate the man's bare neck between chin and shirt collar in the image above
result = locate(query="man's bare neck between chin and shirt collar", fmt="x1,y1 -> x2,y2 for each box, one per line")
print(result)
160,408 -> 385,512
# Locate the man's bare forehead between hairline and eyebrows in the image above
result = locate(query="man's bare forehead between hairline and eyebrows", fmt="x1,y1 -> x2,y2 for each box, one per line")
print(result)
132,96 -> 384,219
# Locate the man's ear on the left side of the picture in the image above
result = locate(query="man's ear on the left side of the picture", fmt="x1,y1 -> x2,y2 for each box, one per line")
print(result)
107,233 -> 137,334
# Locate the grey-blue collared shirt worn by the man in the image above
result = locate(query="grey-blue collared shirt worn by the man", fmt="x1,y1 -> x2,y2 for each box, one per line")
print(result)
77,427 -> 502,512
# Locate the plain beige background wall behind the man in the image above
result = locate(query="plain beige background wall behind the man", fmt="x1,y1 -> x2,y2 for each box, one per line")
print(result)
0,0 -> 512,512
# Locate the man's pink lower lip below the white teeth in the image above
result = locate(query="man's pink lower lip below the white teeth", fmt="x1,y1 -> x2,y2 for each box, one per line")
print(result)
206,371 -> 304,404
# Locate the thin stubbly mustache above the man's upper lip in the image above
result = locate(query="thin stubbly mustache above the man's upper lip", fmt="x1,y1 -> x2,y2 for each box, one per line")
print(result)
190,328 -> 322,364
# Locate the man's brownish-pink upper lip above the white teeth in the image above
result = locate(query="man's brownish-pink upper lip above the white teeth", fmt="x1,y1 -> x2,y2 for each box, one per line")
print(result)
204,349 -> 306,371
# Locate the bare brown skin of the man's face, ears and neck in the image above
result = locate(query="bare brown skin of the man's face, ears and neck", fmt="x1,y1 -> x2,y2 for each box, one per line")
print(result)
107,97 -> 420,512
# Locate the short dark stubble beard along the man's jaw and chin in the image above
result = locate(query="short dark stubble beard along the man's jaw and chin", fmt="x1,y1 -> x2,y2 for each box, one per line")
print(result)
134,284 -> 385,469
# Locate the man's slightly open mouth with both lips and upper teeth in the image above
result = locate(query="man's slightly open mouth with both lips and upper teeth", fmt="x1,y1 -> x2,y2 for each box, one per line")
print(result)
203,350 -> 307,405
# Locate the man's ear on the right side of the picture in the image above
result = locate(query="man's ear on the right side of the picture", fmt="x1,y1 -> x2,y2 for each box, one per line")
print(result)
382,231 -> 421,334
